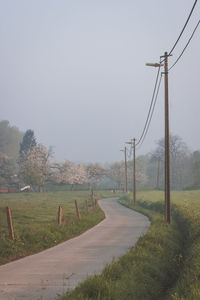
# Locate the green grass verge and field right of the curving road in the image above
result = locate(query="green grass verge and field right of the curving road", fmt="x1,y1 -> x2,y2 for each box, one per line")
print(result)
61,191 -> 200,300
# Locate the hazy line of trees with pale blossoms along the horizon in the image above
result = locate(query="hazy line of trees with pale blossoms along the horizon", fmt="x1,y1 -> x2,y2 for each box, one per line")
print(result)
0,121 -> 200,191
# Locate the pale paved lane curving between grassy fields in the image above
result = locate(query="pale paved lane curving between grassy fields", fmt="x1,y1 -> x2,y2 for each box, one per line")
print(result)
0,198 -> 150,300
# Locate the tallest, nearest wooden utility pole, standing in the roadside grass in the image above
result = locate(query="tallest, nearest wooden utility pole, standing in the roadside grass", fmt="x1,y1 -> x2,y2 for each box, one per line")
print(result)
164,52 -> 171,224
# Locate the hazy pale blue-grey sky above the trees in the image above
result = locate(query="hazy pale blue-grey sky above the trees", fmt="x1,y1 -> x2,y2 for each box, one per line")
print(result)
0,0 -> 200,163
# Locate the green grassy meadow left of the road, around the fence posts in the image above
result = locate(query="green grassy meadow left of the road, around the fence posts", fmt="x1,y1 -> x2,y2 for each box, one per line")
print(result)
0,191 -> 113,264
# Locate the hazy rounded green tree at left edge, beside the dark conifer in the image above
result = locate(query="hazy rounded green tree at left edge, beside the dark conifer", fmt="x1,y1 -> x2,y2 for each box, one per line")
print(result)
0,120 -> 23,160
